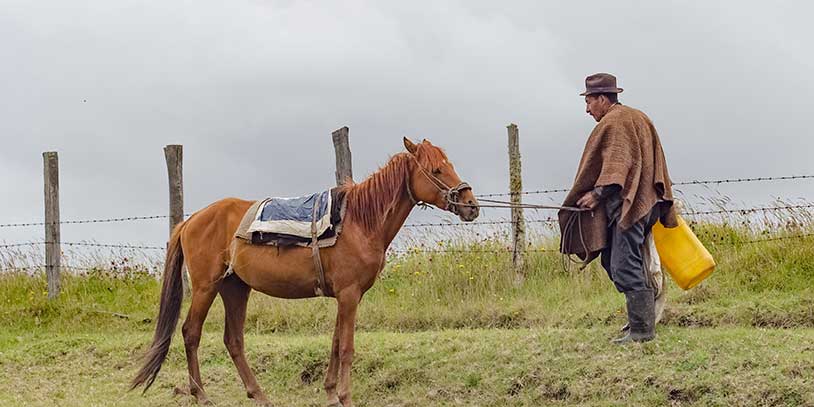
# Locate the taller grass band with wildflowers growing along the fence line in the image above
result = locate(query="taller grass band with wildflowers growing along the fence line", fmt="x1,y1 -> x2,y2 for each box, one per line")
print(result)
0,227 -> 814,333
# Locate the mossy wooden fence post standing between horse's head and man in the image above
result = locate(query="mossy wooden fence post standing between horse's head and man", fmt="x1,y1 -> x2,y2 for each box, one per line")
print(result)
507,123 -> 526,280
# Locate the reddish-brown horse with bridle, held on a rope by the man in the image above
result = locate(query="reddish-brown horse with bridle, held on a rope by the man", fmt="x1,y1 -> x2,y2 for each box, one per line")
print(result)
131,138 -> 479,407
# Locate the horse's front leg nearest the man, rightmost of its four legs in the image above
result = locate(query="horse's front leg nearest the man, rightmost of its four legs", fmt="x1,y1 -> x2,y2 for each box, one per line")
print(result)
337,288 -> 362,407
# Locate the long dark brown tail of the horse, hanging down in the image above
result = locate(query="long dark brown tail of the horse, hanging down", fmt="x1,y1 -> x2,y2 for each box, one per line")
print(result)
130,222 -> 186,392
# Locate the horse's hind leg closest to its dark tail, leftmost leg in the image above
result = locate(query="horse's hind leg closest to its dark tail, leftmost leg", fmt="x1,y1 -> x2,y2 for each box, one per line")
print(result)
181,282 -> 218,404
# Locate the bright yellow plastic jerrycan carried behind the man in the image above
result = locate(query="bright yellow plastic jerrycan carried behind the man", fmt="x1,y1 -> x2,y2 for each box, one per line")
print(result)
653,216 -> 715,290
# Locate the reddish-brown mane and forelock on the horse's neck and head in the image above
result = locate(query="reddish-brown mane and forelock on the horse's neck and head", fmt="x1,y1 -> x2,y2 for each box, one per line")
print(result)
341,141 -> 447,232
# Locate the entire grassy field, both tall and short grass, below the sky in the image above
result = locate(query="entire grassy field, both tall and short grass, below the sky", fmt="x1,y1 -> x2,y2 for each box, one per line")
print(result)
0,225 -> 814,406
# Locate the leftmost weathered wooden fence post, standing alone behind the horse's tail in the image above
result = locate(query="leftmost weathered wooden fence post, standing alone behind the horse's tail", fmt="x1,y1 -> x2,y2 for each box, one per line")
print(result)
42,151 -> 62,300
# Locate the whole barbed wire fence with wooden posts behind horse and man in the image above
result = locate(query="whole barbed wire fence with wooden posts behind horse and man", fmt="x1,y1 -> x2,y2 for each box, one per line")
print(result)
0,125 -> 814,298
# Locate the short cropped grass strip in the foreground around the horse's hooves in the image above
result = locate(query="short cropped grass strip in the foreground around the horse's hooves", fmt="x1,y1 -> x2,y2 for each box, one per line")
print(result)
0,327 -> 814,406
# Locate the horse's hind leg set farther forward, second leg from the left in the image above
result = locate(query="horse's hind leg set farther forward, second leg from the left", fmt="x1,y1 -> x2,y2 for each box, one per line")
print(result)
220,275 -> 271,406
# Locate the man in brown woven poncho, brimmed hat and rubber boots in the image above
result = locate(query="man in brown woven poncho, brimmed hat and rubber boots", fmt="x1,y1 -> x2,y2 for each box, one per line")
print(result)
559,73 -> 677,344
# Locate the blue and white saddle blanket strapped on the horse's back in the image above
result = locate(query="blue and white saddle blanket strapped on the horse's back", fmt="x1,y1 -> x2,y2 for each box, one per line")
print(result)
235,188 -> 345,247
